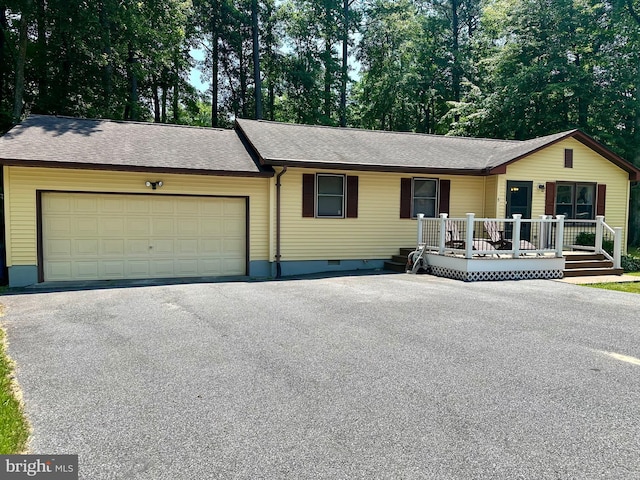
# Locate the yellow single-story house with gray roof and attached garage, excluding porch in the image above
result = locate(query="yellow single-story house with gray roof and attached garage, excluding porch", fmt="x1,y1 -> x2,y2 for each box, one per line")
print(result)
0,115 -> 640,286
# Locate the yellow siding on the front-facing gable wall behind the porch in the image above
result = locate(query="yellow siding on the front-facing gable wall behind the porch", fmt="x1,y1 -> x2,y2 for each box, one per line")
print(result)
497,138 -> 629,245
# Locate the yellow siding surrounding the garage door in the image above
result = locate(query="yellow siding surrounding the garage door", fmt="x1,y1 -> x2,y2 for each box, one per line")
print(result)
4,167 -> 271,266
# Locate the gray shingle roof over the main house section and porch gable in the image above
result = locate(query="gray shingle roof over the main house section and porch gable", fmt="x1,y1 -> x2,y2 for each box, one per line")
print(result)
236,120 -> 629,173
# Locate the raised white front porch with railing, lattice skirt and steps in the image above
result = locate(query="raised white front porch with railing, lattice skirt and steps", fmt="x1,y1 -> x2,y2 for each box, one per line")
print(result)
392,213 -> 622,281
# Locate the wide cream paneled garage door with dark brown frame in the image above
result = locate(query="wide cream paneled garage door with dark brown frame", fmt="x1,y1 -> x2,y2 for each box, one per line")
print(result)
41,192 -> 247,281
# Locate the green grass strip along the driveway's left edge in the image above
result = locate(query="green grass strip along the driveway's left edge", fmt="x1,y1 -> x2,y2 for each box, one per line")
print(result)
0,304 -> 29,455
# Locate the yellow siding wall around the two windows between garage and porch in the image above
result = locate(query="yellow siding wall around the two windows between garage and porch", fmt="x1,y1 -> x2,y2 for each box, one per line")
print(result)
274,168 -> 484,261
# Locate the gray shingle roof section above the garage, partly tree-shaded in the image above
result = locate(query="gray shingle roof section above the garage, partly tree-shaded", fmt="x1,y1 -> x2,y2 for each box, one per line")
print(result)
0,115 -> 272,175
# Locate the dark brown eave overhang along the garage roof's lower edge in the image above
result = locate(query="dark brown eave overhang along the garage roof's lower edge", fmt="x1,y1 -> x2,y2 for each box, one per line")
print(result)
0,158 -> 275,178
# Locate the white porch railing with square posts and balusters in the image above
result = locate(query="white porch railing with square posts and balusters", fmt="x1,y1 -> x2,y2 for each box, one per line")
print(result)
412,213 -> 622,268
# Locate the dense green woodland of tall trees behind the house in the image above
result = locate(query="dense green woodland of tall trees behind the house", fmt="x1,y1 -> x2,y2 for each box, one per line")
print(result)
0,0 -> 640,245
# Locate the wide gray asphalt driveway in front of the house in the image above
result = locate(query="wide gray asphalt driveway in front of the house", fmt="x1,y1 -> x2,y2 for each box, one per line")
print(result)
0,274 -> 640,480
